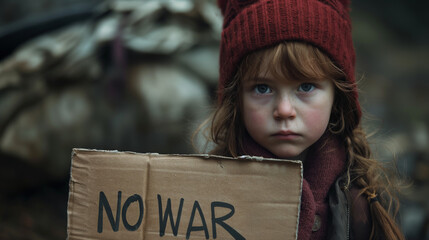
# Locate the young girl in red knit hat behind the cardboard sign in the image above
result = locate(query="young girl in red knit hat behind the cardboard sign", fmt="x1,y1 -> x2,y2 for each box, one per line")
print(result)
196,0 -> 404,239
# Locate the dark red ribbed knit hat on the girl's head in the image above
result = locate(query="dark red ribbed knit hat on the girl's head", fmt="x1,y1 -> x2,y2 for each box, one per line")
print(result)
218,0 -> 361,121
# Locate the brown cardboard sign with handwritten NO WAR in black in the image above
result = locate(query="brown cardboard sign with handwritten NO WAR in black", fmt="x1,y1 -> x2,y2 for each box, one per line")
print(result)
67,149 -> 302,240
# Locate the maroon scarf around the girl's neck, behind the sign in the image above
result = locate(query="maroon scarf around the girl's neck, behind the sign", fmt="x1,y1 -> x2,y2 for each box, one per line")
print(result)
239,132 -> 346,240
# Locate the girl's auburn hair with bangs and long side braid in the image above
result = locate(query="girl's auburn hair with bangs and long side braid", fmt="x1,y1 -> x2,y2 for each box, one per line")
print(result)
194,42 -> 404,240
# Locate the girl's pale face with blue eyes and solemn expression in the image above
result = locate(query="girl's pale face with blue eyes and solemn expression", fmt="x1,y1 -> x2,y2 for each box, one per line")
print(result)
242,66 -> 334,160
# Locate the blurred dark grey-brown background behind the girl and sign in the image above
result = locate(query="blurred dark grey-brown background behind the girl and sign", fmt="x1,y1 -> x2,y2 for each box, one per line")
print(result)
0,0 -> 429,240
